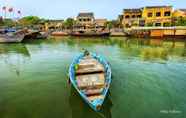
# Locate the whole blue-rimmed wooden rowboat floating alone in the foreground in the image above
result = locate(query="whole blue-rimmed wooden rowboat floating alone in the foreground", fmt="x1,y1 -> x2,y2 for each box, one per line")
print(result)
69,51 -> 111,111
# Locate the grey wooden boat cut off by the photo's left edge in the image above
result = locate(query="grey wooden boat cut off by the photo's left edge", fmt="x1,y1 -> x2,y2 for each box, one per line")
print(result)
0,30 -> 25,43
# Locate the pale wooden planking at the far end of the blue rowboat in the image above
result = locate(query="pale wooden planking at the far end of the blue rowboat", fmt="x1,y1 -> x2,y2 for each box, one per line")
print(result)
76,59 -> 104,75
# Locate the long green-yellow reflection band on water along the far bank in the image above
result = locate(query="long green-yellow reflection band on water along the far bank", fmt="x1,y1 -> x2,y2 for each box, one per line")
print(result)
48,37 -> 186,62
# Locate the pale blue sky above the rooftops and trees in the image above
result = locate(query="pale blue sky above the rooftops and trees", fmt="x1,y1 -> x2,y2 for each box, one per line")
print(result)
0,0 -> 186,19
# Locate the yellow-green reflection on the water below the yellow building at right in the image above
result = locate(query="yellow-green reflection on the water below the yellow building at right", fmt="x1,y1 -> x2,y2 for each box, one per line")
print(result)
112,39 -> 186,61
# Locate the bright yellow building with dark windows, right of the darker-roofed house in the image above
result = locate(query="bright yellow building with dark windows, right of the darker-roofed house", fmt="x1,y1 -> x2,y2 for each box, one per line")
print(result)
142,6 -> 173,26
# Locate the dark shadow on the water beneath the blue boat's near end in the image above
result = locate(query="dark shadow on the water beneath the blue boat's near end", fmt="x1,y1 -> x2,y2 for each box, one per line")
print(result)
69,85 -> 112,118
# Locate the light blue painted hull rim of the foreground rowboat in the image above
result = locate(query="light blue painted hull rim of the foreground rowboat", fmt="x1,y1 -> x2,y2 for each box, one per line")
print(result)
69,53 -> 111,111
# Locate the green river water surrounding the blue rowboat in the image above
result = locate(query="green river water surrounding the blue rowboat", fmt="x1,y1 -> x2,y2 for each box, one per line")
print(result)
0,37 -> 186,118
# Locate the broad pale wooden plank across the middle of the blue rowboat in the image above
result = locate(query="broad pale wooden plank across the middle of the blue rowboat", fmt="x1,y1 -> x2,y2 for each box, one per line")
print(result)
76,73 -> 105,89
